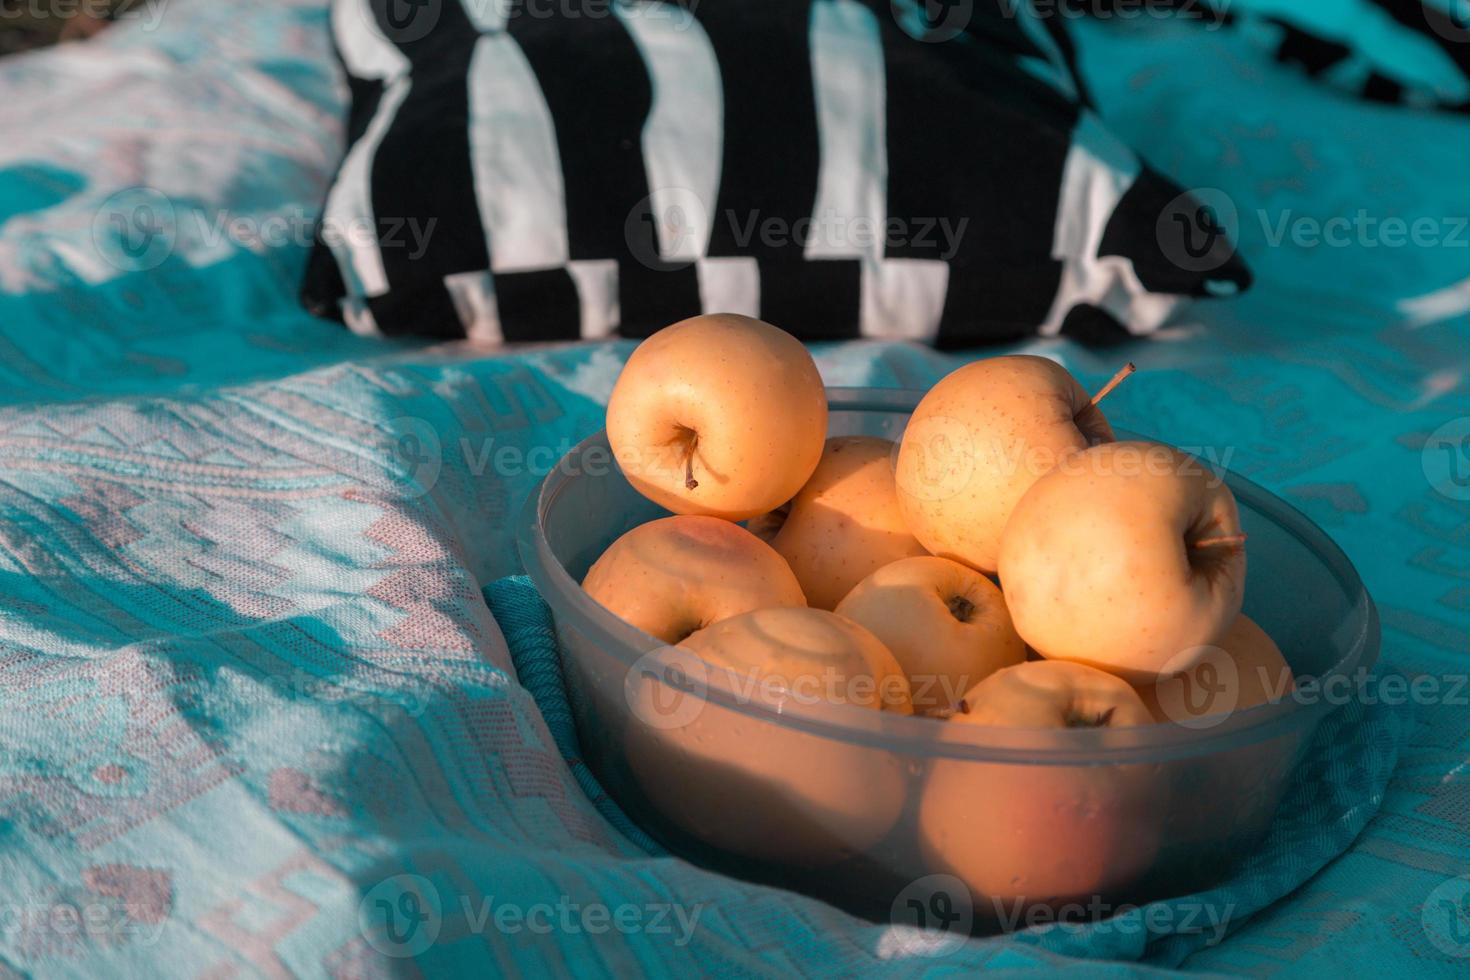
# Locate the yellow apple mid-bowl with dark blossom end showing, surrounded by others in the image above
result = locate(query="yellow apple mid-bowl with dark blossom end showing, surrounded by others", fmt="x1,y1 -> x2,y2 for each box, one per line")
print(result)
836,555 -> 1026,714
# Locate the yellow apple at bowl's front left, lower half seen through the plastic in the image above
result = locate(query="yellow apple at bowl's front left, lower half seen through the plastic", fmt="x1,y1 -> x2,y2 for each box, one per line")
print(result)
625,608 -> 910,868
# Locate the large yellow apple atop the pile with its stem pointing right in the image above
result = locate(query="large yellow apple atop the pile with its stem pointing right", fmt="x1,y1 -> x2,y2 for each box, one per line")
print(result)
1000,442 -> 1245,685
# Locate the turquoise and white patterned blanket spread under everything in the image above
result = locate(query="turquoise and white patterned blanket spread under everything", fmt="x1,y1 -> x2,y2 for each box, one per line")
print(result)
0,0 -> 1470,977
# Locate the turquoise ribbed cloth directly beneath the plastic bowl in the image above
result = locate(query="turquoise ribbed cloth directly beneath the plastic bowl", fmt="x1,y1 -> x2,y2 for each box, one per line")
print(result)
484,576 -> 1413,970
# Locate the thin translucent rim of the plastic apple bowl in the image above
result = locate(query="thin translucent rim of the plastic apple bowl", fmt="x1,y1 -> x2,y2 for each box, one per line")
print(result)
516,386 -> 1380,765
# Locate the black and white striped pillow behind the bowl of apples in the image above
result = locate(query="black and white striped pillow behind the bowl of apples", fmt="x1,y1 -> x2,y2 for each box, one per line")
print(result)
304,0 -> 1248,345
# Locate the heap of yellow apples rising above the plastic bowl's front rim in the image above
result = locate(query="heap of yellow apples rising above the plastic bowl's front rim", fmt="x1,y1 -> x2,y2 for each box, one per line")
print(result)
584,314 -> 1288,890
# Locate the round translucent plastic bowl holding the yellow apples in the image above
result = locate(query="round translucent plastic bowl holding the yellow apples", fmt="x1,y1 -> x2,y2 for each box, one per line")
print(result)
517,388 -> 1379,932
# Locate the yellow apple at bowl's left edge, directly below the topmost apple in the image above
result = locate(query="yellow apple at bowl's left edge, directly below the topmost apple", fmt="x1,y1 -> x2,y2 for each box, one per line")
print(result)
582,514 -> 806,644
